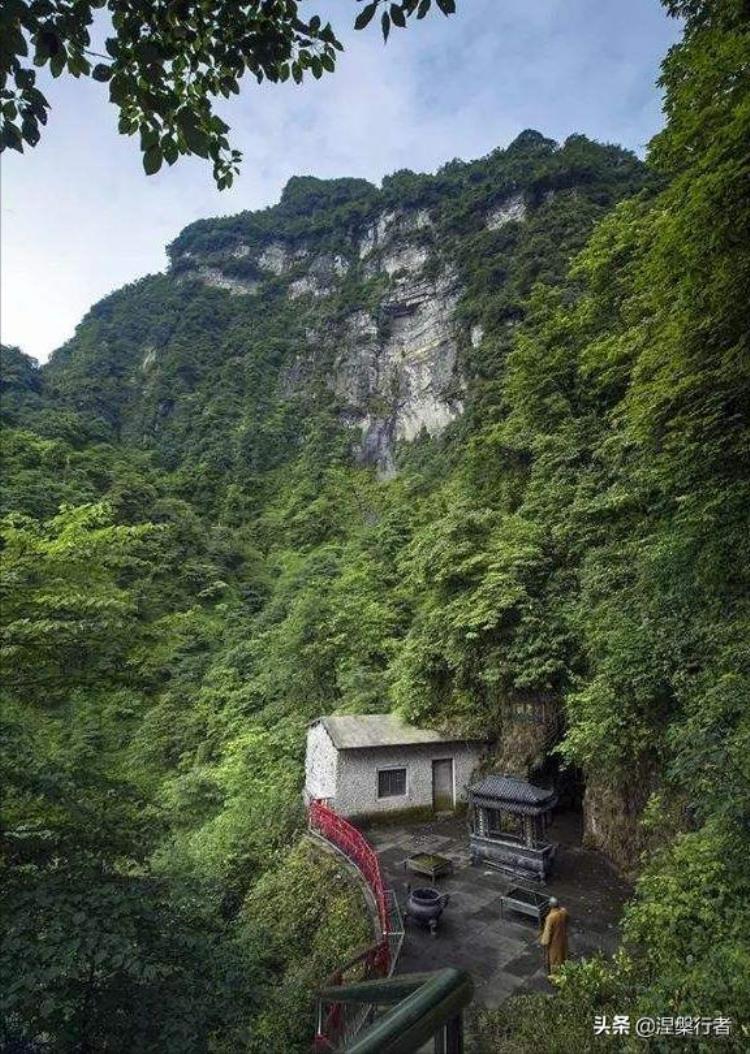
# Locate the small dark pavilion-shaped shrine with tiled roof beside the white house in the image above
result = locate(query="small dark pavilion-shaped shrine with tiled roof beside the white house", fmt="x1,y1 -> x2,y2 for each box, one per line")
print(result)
469,776 -> 557,882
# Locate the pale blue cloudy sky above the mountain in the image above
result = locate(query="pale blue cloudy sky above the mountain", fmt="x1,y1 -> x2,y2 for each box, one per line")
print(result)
0,0 -> 679,362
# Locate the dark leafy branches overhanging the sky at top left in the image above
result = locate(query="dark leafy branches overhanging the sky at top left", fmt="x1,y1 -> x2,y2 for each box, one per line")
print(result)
0,0 -> 455,190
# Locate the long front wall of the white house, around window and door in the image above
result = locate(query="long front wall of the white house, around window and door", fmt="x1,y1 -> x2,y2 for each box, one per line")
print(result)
331,743 -> 480,816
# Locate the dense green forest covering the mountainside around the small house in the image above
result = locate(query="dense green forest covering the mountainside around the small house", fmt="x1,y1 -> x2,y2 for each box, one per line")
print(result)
0,0 -> 750,1054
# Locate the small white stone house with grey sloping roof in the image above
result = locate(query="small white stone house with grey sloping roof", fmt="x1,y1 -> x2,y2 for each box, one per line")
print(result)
304,714 -> 482,816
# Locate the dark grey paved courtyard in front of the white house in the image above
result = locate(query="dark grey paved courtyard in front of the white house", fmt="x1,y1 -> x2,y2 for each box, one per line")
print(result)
367,814 -> 630,1007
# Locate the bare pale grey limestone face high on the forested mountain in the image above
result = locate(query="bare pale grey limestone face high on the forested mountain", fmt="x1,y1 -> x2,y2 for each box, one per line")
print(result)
172,202 -> 476,476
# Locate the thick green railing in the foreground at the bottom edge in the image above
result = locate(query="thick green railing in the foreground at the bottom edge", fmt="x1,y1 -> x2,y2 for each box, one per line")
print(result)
320,967 -> 474,1054
